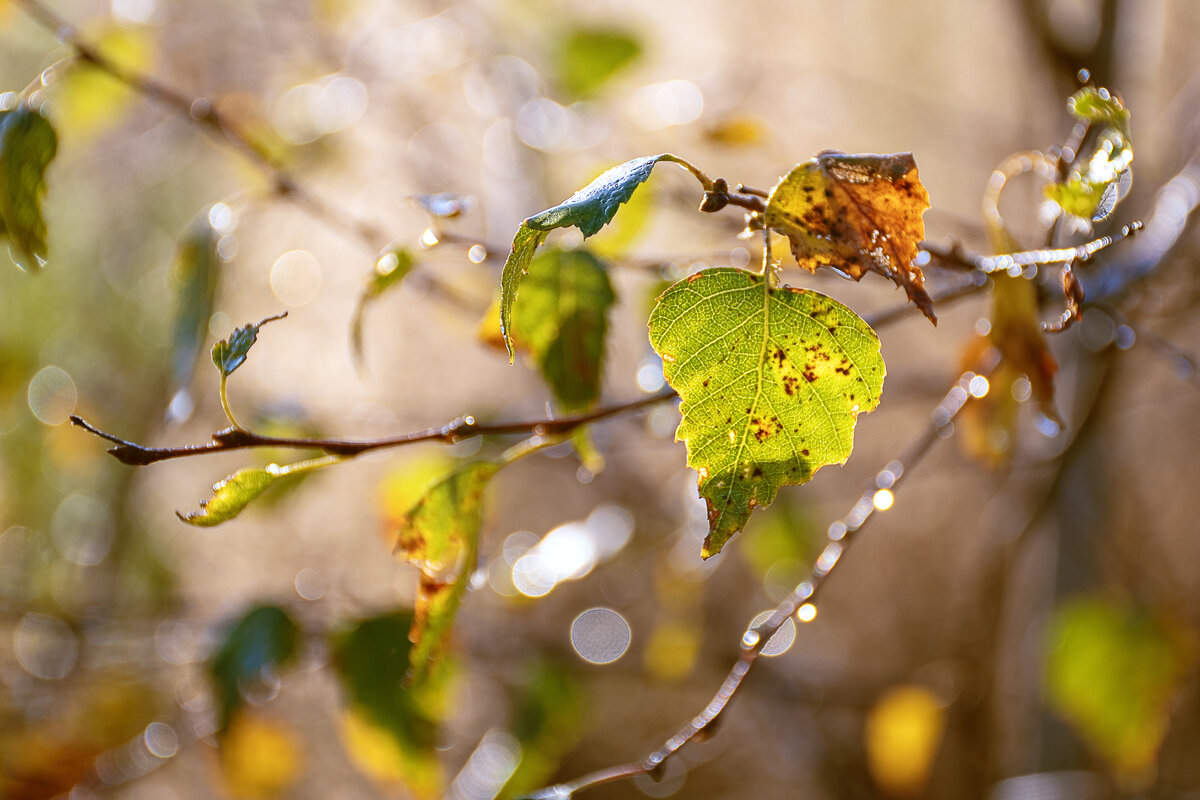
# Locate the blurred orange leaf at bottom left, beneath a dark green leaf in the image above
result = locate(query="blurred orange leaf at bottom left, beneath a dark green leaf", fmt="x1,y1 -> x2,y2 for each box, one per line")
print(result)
221,710 -> 302,798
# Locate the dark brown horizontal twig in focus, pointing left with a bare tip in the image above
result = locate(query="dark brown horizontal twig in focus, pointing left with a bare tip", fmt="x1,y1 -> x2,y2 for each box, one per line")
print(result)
71,391 -> 676,467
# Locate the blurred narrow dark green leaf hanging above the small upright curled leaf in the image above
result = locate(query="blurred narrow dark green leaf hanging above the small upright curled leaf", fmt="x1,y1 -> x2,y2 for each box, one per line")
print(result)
170,210 -> 221,389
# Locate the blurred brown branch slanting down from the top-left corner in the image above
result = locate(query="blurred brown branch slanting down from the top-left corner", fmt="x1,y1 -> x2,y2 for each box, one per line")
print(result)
16,0 -> 385,252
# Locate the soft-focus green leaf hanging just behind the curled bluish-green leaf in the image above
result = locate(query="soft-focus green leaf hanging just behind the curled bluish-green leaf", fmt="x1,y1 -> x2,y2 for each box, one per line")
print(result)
514,247 -> 617,413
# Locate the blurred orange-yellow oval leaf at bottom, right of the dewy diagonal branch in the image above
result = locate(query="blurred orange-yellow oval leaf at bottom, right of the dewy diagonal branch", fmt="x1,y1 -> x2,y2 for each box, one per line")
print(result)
864,685 -> 946,798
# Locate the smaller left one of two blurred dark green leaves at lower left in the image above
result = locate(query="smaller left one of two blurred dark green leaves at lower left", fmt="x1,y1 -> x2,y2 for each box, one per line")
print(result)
209,606 -> 300,730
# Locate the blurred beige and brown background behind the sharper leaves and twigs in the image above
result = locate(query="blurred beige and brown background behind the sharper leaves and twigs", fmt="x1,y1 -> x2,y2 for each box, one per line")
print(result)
0,0 -> 1200,800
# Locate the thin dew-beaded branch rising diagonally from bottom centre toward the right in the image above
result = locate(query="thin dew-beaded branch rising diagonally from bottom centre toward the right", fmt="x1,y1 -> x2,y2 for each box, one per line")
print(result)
527,372 -> 980,800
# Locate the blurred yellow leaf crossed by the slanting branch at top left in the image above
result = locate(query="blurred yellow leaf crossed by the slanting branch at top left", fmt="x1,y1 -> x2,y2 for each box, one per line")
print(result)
53,25 -> 157,138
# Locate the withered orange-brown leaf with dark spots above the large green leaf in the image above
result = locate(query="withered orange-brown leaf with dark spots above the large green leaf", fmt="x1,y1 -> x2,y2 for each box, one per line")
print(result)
764,151 -> 937,325
